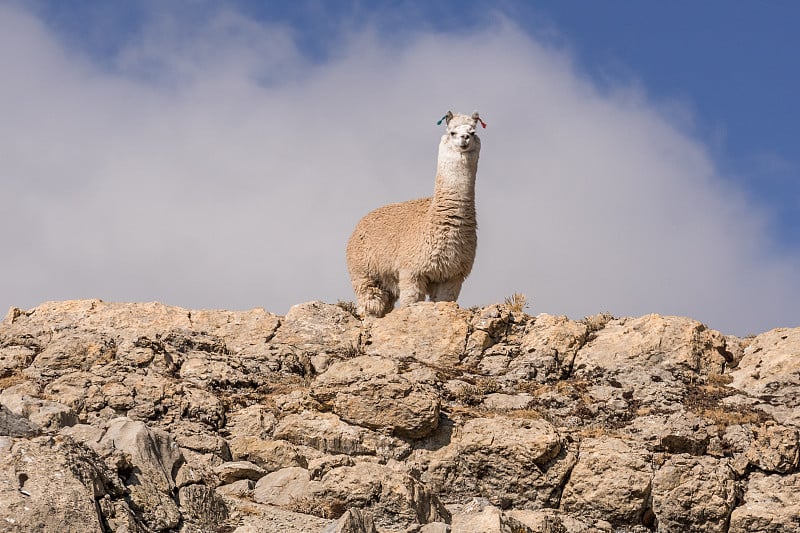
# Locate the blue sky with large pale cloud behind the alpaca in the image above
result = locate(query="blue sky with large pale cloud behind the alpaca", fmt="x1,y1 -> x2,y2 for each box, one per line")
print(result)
0,0 -> 800,335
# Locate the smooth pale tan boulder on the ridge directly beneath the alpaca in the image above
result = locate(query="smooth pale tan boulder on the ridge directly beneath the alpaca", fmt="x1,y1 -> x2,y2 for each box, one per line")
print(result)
364,302 -> 470,366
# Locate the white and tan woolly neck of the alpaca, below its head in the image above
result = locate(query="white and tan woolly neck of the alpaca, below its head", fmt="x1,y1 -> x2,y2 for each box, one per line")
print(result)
431,148 -> 478,220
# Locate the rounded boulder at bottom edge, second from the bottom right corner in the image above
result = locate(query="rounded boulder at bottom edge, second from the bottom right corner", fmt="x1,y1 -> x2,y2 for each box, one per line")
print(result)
652,455 -> 737,532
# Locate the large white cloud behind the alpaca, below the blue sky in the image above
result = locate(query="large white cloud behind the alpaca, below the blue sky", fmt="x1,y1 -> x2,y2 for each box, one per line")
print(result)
0,6 -> 800,334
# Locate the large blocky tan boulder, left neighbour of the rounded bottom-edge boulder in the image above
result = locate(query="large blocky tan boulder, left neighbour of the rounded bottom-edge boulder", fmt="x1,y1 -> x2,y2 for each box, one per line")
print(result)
561,436 -> 653,527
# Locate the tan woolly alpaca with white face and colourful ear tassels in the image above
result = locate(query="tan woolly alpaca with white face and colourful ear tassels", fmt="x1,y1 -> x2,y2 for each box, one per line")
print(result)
347,111 -> 486,317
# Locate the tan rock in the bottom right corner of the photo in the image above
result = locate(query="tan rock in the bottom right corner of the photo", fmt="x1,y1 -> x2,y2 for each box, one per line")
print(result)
728,473 -> 800,533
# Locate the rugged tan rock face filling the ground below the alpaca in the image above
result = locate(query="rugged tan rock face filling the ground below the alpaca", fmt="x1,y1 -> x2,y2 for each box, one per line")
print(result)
0,300 -> 800,533
